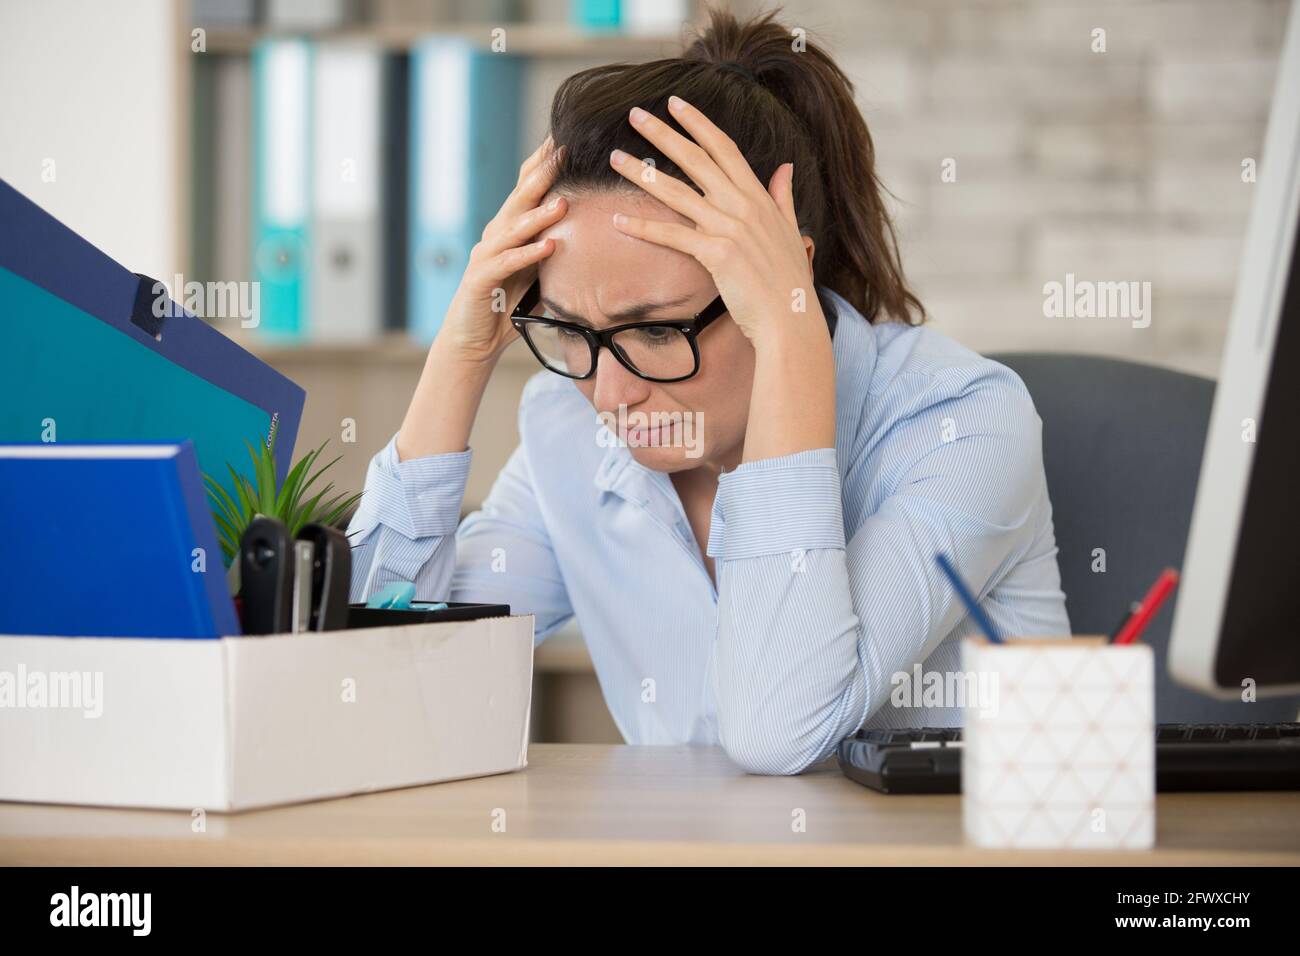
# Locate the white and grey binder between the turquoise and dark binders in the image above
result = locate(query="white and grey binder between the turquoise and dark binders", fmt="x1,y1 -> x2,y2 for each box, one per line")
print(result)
313,43 -> 387,342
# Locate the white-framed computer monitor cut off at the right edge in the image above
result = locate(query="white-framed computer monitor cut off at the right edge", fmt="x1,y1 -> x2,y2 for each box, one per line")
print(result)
1169,1 -> 1300,698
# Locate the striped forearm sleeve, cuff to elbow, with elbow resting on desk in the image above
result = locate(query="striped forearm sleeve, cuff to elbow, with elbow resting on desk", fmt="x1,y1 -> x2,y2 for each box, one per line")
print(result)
709,449 -> 866,774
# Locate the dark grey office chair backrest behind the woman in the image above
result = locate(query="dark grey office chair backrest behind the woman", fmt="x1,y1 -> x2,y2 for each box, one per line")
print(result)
989,352 -> 1300,723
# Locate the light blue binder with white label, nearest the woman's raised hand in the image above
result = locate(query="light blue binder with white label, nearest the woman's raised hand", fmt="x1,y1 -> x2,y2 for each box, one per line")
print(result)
408,38 -> 523,343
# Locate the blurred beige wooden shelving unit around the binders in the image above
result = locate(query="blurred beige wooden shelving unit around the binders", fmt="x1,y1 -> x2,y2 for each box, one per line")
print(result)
183,0 -> 718,510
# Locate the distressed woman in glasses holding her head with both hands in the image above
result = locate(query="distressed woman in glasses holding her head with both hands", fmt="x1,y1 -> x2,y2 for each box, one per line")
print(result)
352,14 -> 1069,774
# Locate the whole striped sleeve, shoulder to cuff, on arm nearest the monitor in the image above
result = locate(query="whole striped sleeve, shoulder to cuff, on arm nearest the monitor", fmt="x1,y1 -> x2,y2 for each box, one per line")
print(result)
709,374 -> 1043,774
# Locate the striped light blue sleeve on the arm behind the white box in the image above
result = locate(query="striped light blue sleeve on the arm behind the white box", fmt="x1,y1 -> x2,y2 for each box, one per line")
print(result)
348,436 -> 573,640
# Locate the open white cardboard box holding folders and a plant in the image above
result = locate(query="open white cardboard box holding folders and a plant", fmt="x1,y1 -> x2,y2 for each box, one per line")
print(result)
0,615 -> 533,810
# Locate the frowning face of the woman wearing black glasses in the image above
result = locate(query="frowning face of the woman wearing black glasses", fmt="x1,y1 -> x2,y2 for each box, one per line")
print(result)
538,191 -> 754,472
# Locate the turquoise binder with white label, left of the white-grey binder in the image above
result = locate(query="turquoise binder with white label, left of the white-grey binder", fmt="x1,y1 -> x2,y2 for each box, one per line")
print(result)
252,39 -> 312,341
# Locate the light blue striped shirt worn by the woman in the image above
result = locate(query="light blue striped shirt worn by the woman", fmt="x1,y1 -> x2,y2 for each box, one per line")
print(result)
351,295 -> 1070,774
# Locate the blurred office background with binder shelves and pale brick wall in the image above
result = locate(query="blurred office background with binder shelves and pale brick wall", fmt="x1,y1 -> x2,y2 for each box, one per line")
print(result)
0,0 -> 1290,740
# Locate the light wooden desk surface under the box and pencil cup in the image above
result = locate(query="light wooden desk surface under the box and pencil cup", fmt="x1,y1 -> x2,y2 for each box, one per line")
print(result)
0,744 -> 1300,865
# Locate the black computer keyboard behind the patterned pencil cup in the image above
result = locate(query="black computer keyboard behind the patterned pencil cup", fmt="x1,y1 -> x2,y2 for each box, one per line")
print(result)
837,723 -> 1300,793
